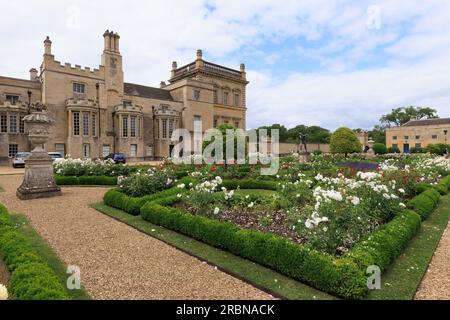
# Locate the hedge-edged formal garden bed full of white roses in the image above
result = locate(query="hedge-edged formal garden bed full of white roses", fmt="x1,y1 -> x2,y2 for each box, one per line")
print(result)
86,155 -> 450,298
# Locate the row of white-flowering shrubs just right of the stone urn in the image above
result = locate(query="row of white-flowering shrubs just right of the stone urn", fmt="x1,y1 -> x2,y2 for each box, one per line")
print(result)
53,158 -> 131,177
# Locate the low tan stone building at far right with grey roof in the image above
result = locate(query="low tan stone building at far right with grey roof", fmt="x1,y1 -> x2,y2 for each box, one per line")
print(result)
386,118 -> 450,153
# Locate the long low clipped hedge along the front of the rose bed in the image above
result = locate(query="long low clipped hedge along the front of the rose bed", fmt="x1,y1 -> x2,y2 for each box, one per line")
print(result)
141,200 -> 367,299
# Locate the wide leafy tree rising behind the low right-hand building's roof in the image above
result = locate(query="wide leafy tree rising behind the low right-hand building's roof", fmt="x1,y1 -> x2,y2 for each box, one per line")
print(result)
380,106 -> 438,127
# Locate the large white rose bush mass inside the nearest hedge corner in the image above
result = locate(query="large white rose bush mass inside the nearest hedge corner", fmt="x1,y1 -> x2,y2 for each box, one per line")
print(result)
298,172 -> 405,254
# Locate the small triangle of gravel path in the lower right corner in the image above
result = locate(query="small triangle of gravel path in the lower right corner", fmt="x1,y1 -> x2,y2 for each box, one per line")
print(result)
415,222 -> 450,300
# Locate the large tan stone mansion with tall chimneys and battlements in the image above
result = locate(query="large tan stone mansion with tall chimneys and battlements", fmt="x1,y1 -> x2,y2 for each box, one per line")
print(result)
0,30 -> 248,161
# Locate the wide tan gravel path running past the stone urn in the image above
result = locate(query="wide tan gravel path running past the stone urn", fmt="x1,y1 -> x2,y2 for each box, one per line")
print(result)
0,175 -> 272,299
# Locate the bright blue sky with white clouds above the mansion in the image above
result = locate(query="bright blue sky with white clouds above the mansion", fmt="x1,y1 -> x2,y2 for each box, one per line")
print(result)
0,0 -> 450,129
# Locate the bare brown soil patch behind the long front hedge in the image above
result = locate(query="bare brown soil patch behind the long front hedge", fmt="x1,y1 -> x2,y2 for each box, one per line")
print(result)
174,202 -> 306,243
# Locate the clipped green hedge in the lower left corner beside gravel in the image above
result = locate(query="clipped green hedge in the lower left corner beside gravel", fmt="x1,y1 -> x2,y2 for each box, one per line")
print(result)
0,204 -> 69,300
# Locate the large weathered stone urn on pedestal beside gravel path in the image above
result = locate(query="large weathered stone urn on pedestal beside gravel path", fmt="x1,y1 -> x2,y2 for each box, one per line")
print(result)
16,102 -> 61,200
